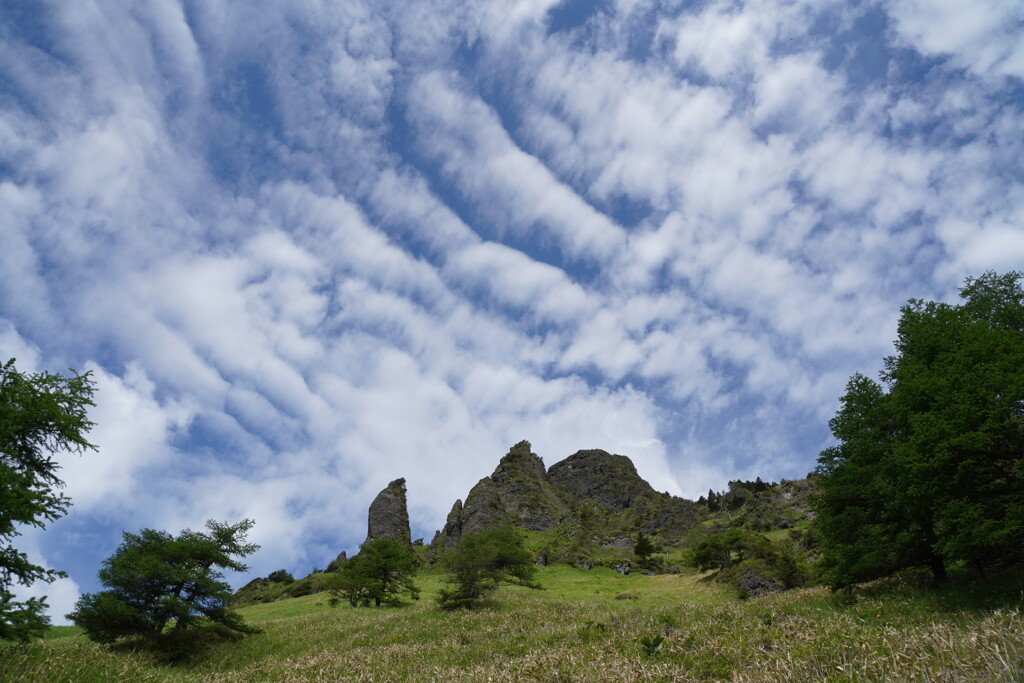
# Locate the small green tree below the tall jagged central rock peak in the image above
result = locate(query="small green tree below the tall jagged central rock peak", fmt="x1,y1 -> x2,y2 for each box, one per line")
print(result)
437,527 -> 541,609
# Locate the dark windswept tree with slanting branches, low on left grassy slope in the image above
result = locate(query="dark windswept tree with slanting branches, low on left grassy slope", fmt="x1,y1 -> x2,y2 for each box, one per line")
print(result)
68,519 -> 259,643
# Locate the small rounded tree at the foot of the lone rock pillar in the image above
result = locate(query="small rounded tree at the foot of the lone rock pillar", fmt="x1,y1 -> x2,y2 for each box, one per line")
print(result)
330,537 -> 420,607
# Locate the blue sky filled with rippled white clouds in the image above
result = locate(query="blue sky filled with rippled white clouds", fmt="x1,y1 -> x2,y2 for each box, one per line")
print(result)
0,0 -> 1024,623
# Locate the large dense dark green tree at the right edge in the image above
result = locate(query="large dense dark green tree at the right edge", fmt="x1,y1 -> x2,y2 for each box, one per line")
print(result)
817,272 -> 1024,588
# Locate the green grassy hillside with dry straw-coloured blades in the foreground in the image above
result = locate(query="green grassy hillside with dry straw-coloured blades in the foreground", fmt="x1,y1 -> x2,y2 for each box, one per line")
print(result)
0,566 -> 1024,682
